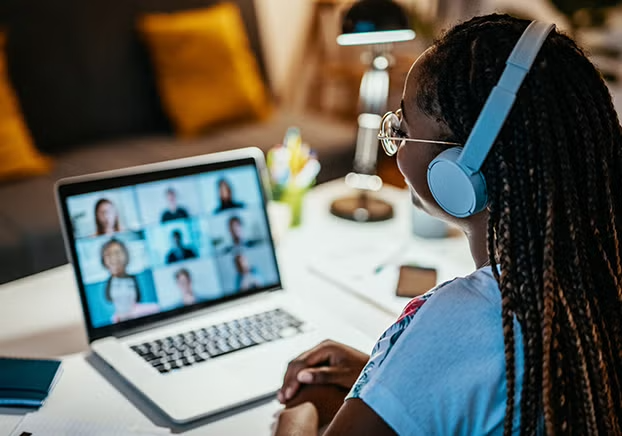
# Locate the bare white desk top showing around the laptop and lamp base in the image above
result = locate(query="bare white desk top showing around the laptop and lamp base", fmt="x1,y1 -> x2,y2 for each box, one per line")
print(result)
0,182 -> 472,435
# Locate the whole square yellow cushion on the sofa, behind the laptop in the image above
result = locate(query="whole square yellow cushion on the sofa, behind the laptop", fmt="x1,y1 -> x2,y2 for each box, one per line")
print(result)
138,3 -> 271,137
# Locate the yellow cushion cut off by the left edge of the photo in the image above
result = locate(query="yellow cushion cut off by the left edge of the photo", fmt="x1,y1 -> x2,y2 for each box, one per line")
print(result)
0,32 -> 50,181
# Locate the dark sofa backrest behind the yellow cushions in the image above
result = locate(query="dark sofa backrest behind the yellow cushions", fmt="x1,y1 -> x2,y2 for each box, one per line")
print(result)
0,0 -> 265,152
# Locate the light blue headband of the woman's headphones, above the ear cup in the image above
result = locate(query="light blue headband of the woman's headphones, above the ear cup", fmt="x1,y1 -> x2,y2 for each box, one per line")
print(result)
457,21 -> 555,173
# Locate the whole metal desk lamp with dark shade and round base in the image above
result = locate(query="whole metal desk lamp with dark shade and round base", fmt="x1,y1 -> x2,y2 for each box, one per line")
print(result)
330,0 -> 415,222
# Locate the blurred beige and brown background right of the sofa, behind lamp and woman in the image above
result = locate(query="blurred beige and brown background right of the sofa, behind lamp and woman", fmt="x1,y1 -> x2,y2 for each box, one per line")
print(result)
266,0 -> 622,182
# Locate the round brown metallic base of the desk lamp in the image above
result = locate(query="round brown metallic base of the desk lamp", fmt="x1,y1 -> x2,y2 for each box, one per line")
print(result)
330,191 -> 393,222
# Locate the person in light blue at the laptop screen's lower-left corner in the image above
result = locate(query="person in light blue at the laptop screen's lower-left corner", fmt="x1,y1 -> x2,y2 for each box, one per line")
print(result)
101,238 -> 159,323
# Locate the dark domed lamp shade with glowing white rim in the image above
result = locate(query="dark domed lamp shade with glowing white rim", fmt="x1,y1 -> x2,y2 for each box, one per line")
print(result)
337,0 -> 415,45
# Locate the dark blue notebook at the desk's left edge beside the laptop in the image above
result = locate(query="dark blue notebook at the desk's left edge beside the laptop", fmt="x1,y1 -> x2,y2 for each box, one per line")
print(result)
0,358 -> 61,408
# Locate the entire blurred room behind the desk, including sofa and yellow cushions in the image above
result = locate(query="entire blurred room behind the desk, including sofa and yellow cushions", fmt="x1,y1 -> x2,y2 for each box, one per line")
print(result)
0,0 -> 622,283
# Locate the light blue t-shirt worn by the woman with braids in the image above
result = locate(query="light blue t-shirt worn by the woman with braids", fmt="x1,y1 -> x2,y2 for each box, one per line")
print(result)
348,267 -> 524,436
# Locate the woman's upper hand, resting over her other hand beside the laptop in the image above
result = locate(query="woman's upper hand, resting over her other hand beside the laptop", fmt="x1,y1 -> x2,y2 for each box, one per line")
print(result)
277,340 -> 369,403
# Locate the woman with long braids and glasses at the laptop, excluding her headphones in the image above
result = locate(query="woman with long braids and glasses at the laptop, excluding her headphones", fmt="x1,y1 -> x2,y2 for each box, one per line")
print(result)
277,15 -> 622,436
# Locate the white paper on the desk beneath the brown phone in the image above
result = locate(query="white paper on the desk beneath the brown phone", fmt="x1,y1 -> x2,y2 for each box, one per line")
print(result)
308,237 -> 474,317
